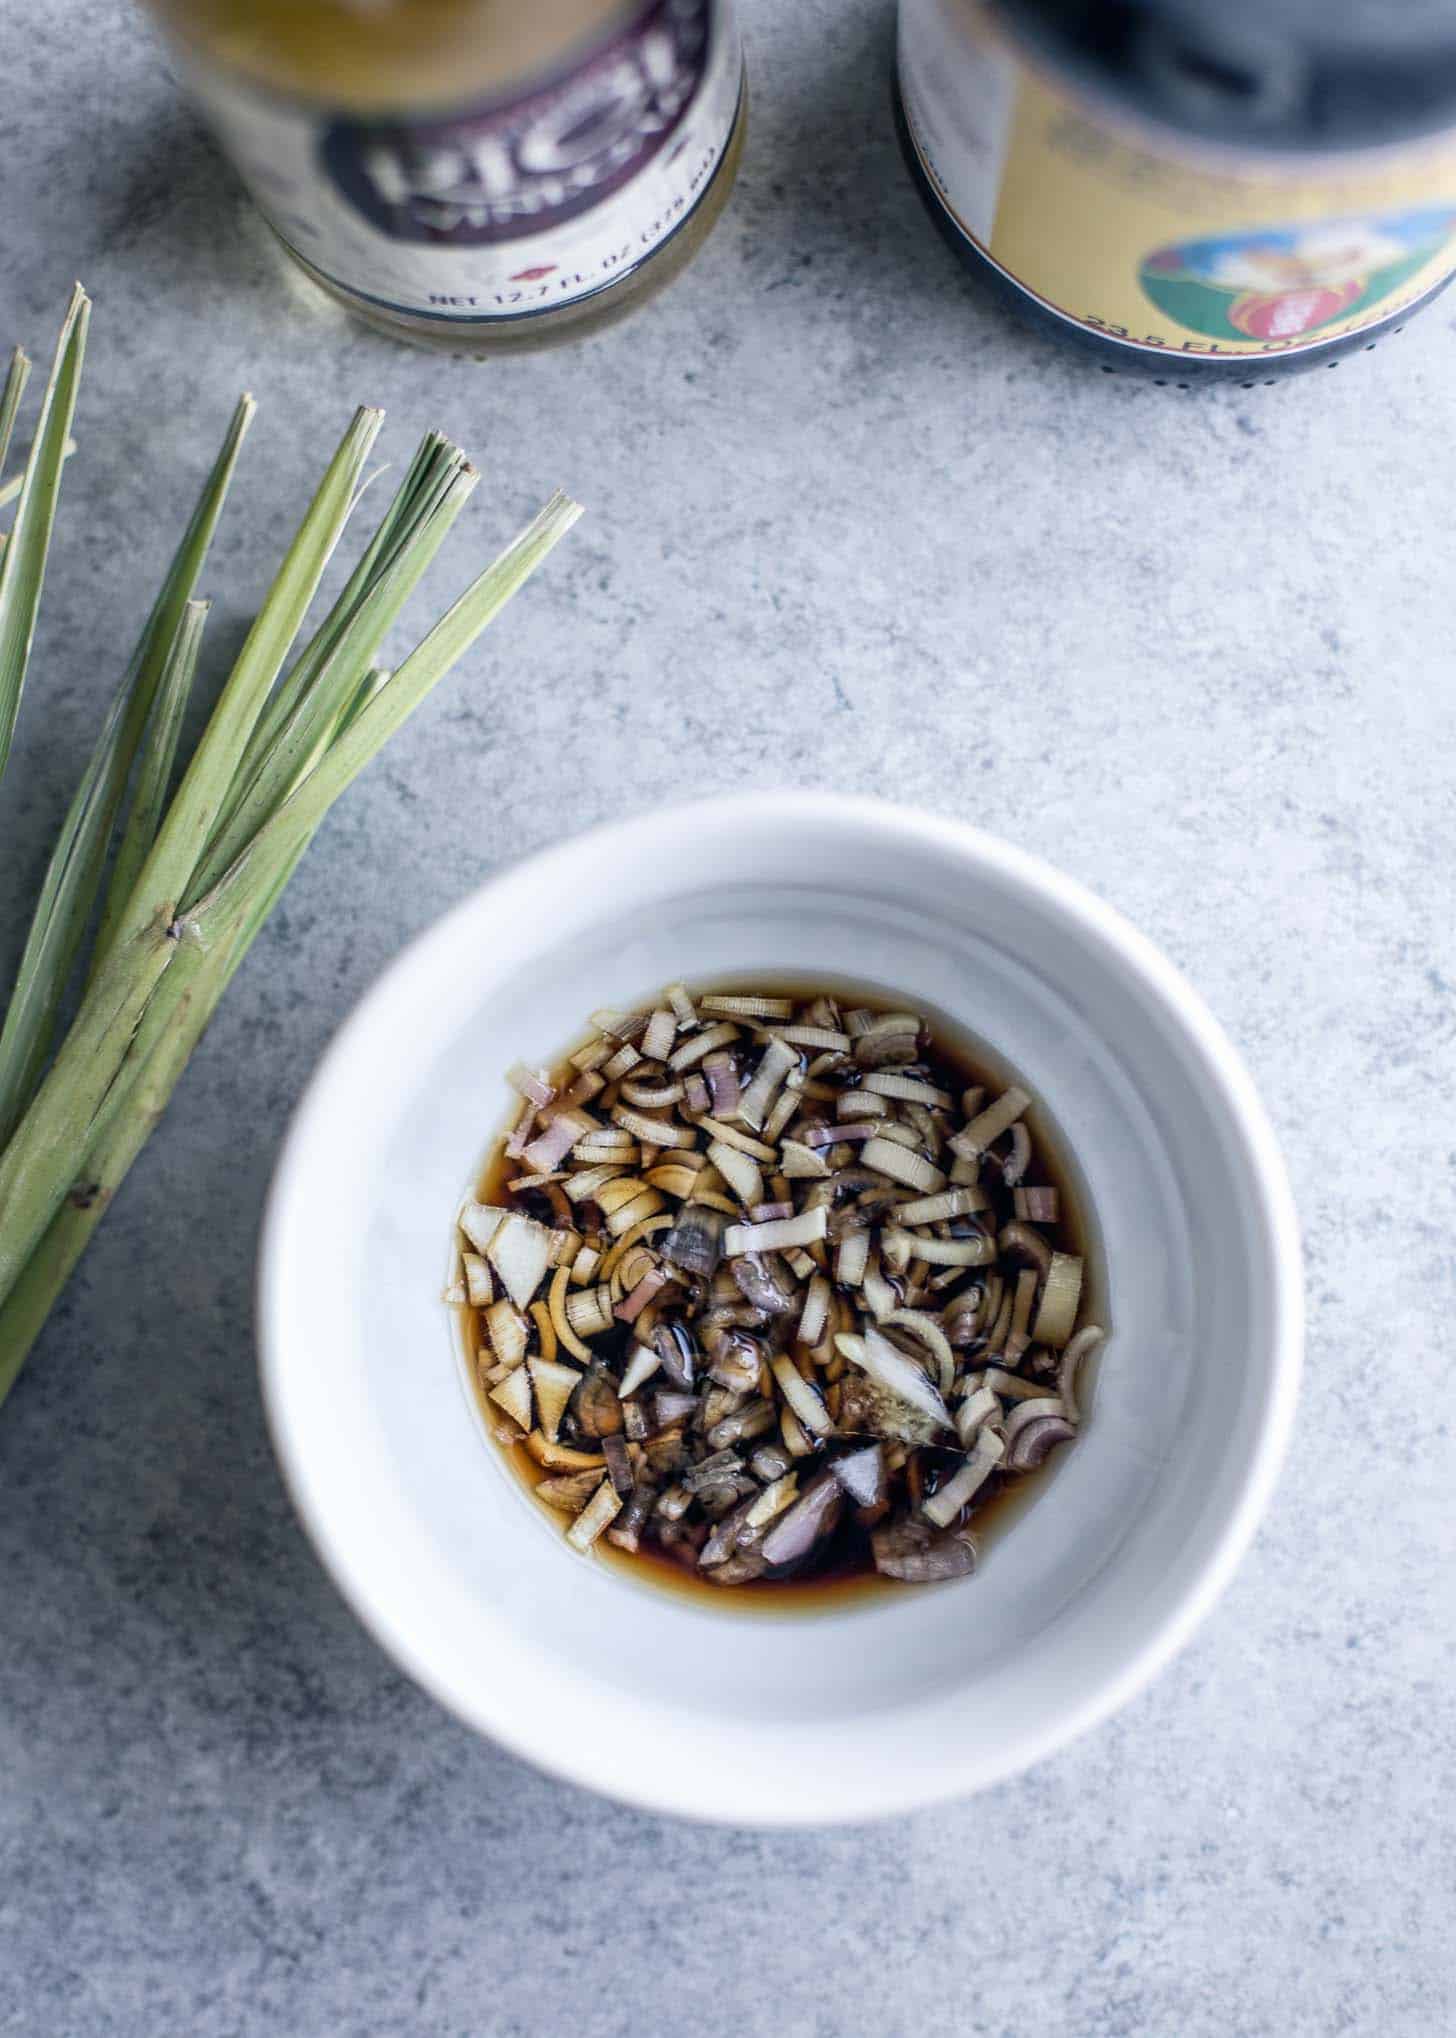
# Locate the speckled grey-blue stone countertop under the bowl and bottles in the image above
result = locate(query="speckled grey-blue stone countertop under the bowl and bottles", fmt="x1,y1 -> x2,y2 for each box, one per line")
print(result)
0,0 -> 1456,2038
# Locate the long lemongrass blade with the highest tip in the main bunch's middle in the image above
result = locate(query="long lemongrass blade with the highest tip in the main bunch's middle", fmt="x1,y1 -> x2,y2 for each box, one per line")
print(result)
105,410 -> 383,961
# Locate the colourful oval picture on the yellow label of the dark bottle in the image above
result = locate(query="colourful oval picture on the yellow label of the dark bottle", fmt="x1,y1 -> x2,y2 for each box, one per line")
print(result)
1138,206 -> 1456,340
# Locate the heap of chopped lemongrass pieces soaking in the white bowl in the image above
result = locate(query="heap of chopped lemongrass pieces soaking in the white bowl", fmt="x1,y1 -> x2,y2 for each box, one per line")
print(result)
457,984 -> 1101,1586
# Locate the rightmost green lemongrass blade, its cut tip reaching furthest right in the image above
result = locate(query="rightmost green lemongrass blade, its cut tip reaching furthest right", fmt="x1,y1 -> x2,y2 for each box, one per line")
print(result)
190,491 -> 581,940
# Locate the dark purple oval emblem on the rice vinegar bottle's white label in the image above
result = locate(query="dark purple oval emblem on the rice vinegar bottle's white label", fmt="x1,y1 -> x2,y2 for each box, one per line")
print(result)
320,0 -> 712,249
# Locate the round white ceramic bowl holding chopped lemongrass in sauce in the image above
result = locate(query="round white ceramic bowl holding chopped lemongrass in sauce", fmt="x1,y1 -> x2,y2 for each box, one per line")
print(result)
259,795 -> 1301,1824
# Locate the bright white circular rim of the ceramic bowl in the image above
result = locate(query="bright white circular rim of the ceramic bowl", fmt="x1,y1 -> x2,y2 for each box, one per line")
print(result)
255,791 -> 1303,1826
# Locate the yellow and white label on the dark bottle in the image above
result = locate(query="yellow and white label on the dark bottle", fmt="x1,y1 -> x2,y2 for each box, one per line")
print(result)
899,0 -> 1456,359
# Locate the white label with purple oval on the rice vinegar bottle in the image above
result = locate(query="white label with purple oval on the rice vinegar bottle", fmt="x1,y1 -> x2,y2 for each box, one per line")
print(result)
190,0 -> 742,324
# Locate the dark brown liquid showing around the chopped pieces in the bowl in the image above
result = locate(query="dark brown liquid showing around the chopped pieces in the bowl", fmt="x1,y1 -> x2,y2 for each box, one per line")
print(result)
457,970 -> 1107,1614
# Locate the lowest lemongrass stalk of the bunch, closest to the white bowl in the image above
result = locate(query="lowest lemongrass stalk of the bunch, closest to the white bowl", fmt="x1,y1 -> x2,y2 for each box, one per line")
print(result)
0,827 -> 306,1402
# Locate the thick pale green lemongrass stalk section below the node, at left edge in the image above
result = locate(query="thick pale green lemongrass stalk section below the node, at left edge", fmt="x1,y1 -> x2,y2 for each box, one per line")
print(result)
0,919 -> 184,1298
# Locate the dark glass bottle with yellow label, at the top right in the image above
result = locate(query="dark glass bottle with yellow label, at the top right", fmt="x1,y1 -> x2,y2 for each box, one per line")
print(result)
897,0 -> 1456,387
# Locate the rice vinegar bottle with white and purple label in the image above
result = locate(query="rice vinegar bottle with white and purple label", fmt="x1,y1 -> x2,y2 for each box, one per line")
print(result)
149,0 -> 744,353
